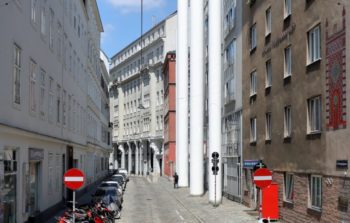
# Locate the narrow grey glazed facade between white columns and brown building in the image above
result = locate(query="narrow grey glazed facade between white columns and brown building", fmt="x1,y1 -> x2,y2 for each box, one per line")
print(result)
222,0 -> 245,202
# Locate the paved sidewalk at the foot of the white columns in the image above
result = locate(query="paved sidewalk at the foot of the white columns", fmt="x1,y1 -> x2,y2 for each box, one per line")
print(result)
156,177 -> 258,223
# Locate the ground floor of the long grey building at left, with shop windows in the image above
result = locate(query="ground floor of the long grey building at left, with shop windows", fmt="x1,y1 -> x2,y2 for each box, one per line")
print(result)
0,124 -> 109,223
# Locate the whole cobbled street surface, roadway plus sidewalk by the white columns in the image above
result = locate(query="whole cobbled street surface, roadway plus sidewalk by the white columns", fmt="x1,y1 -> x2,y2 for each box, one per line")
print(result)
117,177 -> 258,223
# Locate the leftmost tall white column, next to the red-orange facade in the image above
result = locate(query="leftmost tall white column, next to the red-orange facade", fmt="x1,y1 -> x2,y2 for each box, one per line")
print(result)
176,0 -> 188,187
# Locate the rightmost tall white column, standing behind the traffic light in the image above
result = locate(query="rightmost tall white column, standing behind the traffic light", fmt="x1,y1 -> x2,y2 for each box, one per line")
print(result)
208,0 -> 222,205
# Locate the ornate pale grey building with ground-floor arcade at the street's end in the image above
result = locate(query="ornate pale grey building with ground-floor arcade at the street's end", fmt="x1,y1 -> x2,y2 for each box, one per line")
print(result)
110,13 -> 177,175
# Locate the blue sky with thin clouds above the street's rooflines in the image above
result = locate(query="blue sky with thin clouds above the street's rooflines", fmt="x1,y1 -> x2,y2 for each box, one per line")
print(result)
97,0 -> 177,58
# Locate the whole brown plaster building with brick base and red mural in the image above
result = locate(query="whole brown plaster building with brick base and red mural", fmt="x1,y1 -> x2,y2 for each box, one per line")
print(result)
242,0 -> 350,222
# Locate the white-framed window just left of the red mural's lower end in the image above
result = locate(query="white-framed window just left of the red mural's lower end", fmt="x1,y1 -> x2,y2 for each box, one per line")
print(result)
307,96 -> 321,133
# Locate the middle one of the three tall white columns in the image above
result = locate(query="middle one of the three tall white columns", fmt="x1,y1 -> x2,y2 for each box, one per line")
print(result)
190,0 -> 204,195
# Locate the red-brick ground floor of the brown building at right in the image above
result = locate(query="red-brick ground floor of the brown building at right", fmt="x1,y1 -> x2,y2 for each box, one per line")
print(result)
243,168 -> 350,223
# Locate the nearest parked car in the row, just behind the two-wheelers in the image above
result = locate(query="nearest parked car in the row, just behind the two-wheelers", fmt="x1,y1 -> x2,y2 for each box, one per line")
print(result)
92,187 -> 122,211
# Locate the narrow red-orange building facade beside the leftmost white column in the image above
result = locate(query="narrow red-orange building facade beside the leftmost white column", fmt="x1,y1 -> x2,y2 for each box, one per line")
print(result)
162,52 -> 176,178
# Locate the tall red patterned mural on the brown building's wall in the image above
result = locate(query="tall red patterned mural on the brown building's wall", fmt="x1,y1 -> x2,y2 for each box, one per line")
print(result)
326,8 -> 346,130
